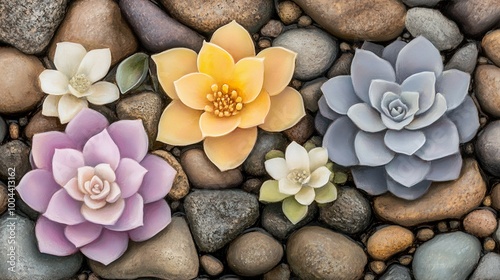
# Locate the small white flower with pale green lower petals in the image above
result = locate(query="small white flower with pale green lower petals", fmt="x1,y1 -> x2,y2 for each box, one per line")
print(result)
259,142 -> 337,224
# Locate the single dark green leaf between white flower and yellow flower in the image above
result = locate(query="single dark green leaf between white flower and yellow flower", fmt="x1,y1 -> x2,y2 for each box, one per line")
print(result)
116,53 -> 149,94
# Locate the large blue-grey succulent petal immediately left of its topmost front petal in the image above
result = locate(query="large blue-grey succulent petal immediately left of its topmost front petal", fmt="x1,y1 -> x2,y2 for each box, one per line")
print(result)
351,49 -> 396,103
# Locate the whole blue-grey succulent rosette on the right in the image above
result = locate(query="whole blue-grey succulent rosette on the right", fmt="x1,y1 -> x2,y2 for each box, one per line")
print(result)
316,37 -> 479,199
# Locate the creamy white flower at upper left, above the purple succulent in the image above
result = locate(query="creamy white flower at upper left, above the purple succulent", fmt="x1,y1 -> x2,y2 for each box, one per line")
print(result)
39,42 -> 119,124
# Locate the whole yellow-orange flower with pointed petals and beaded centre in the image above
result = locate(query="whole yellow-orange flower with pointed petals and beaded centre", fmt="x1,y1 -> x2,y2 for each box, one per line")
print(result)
152,21 -> 305,171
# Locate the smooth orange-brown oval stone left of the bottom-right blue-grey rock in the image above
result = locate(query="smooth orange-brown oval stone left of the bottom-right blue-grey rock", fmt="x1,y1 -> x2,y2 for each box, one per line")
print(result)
366,225 -> 415,261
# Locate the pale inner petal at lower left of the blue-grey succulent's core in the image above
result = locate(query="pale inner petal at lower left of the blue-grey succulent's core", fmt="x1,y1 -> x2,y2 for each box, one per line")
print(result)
347,103 -> 386,132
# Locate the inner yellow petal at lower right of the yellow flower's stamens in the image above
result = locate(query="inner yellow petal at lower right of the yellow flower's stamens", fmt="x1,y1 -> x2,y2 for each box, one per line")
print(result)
239,91 -> 271,128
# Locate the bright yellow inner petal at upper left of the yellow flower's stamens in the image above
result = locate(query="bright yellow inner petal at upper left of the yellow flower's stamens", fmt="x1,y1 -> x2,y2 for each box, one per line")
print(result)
197,42 -> 234,85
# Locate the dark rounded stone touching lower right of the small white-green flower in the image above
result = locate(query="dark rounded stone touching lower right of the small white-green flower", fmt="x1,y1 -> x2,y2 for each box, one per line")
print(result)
319,187 -> 372,234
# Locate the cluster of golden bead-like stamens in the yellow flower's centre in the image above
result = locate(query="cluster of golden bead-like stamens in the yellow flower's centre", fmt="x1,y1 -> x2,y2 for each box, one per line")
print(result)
205,84 -> 243,117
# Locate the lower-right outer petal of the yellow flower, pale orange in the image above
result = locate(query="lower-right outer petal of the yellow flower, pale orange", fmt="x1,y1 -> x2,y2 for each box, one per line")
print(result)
259,87 -> 306,132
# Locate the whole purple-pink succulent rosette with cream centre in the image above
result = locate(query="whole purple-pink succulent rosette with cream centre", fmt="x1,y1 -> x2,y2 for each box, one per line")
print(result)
17,108 -> 176,265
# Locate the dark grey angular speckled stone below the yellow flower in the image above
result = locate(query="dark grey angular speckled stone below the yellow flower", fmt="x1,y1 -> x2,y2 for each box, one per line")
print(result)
184,190 -> 259,253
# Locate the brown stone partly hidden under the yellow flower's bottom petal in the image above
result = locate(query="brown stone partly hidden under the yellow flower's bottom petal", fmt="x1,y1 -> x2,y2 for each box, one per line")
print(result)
181,149 -> 243,189
